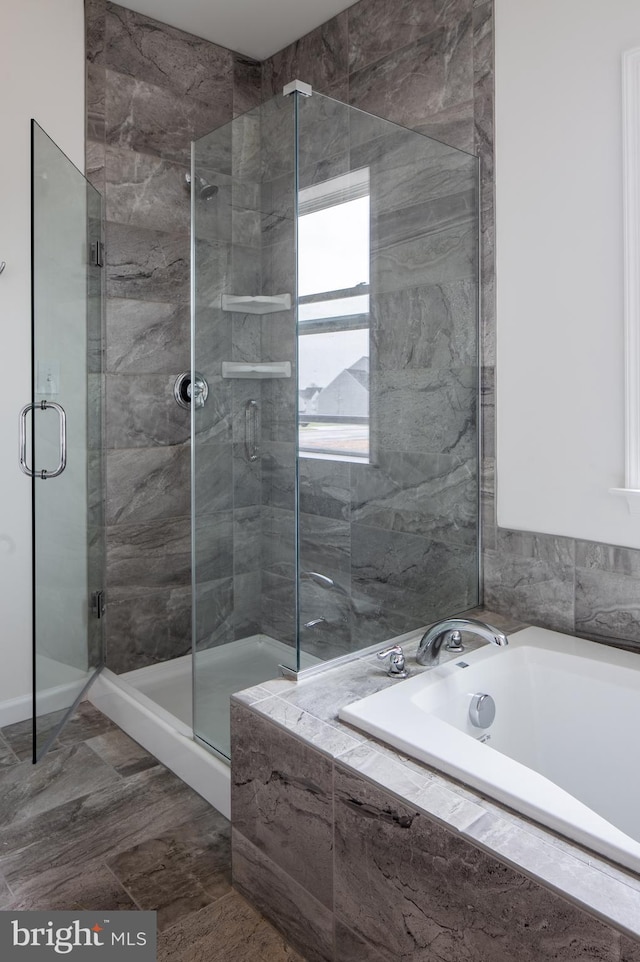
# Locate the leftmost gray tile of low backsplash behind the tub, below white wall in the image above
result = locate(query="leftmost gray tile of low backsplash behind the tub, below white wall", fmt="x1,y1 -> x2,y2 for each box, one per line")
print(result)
484,550 -> 574,633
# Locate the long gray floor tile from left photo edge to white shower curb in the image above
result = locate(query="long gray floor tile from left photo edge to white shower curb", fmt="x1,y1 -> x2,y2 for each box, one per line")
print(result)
0,766 -> 209,886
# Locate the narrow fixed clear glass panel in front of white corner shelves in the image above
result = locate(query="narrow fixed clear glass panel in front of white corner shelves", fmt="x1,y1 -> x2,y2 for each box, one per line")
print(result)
192,97 -> 297,757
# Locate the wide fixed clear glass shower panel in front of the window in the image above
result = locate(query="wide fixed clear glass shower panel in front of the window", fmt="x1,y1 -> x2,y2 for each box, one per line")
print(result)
298,93 -> 478,660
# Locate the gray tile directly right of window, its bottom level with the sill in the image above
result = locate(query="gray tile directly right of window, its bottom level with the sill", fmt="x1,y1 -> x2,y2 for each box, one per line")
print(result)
371,367 -> 477,459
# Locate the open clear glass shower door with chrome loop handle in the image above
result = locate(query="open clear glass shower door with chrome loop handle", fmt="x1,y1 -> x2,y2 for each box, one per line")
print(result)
29,123 -> 105,760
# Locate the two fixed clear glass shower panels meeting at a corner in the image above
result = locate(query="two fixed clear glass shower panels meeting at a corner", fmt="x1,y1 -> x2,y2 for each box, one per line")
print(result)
191,82 -> 478,755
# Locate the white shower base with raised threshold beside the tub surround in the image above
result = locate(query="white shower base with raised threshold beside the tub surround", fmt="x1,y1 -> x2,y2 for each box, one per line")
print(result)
89,635 -> 308,818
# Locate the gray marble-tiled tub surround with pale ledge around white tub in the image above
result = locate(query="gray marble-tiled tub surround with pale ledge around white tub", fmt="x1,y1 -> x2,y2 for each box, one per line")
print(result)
232,613 -> 640,962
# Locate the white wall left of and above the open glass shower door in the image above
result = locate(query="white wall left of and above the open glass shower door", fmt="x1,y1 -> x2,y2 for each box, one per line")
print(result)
0,0 -> 84,703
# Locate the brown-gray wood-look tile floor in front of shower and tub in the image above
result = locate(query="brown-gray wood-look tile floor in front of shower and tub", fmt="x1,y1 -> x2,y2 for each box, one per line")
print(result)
0,702 -> 304,962
